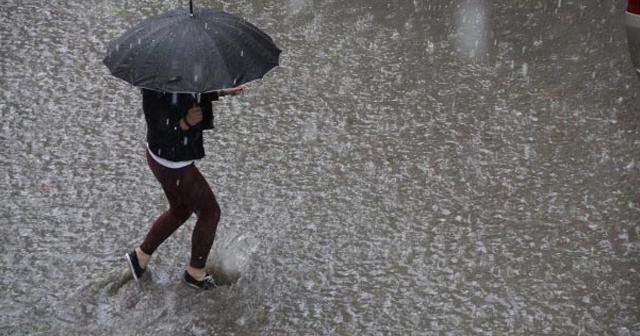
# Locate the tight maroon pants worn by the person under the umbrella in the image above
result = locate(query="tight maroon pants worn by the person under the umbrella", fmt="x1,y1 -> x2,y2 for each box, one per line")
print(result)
140,152 -> 220,268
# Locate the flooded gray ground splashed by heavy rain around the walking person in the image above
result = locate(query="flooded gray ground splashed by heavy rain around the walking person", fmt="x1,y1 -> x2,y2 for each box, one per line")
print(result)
0,0 -> 640,336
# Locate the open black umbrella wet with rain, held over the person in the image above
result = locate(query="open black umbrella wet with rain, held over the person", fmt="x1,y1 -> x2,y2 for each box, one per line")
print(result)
103,1 -> 280,93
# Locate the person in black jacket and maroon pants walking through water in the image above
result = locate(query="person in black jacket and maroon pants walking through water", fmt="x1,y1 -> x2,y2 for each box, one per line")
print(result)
125,86 -> 245,290
